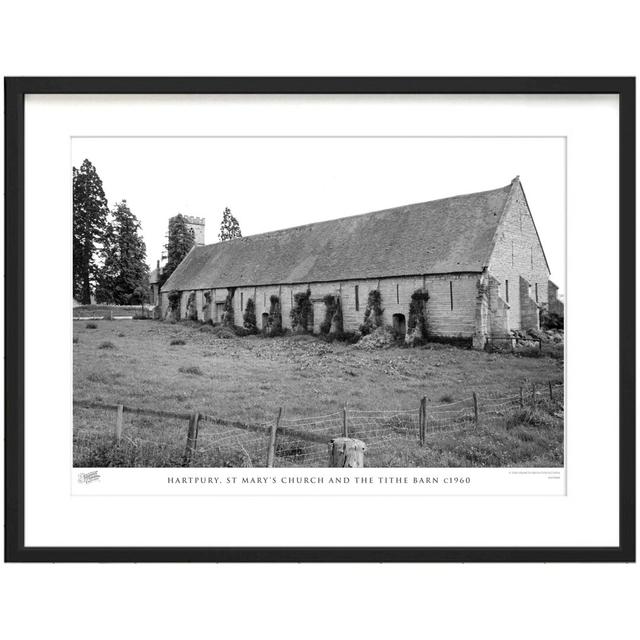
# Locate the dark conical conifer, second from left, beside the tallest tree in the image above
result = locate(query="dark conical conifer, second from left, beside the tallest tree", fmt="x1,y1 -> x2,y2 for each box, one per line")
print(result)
96,200 -> 149,304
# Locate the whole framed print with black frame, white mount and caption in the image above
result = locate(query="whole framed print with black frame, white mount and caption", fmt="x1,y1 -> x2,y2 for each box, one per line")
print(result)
5,78 -> 635,562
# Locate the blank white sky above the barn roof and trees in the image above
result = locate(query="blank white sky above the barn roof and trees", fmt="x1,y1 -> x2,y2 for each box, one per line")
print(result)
72,137 -> 566,293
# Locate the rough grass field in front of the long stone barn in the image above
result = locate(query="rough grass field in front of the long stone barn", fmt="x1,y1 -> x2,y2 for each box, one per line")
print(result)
73,320 -> 563,467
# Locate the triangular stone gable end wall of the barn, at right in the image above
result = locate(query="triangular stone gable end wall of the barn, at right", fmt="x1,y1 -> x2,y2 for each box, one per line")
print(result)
489,181 -> 549,329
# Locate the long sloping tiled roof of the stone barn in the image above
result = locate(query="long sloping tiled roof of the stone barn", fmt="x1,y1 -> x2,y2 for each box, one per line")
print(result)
162,178 -> 518,291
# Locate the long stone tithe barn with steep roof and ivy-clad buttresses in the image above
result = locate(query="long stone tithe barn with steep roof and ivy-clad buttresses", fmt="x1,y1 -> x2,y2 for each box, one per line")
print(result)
160,177 -> 549,348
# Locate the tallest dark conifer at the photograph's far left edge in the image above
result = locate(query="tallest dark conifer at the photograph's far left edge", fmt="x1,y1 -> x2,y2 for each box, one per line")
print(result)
73,159 -> 109,304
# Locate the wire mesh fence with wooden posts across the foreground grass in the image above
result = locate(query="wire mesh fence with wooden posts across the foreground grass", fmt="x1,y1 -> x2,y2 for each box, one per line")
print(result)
73,382 -> 564,467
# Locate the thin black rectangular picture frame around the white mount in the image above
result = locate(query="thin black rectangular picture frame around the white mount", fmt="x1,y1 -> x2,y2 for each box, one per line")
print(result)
4,77 -> 636,562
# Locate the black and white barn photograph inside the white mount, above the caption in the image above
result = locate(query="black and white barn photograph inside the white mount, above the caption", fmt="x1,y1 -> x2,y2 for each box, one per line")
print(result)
69,136 -> 567,470
